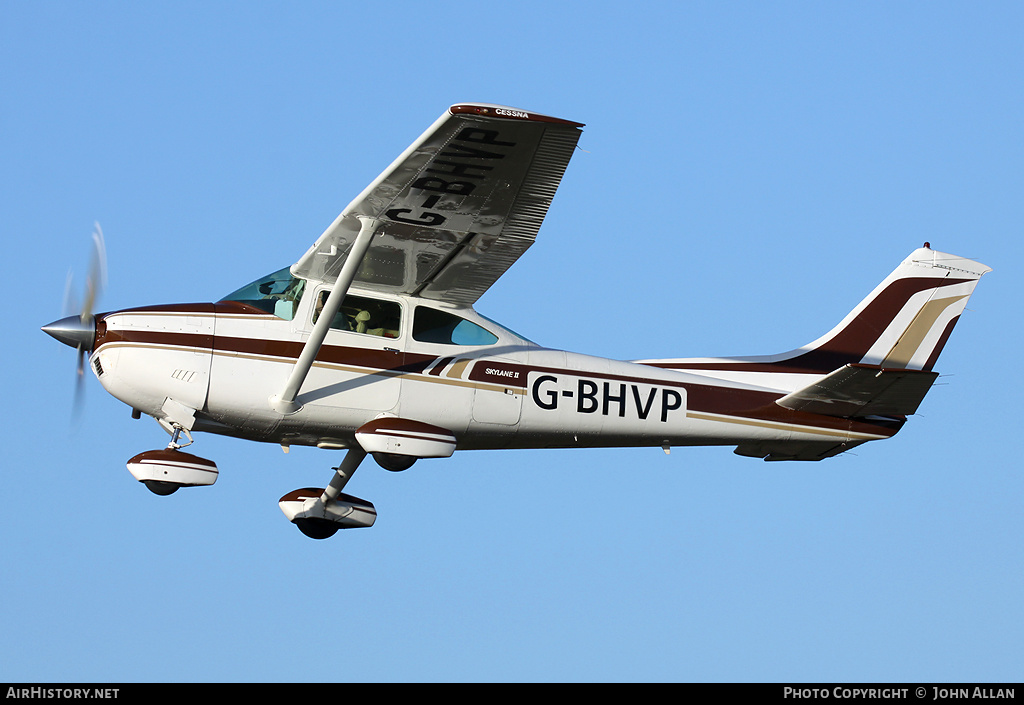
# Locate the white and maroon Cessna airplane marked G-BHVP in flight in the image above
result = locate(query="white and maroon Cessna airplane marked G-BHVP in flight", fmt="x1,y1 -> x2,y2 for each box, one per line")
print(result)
42,103 -> 991,539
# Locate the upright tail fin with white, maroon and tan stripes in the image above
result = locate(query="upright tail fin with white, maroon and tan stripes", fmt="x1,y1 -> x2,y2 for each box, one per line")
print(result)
637,243 -> 991,375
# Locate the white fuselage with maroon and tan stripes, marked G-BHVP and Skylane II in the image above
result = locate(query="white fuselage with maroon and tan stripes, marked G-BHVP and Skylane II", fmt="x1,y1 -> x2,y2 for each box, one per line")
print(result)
92,282 -> 895,457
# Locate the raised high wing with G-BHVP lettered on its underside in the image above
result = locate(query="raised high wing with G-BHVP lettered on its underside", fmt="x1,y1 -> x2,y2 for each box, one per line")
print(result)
292,103 -> 583,305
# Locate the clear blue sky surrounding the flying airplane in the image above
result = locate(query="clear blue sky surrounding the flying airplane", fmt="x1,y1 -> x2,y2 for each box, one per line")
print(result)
0,0 -> 1024,682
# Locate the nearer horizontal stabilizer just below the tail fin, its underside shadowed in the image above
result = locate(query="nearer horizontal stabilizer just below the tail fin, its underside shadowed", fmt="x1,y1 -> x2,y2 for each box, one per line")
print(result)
775,364 -> 939,417
